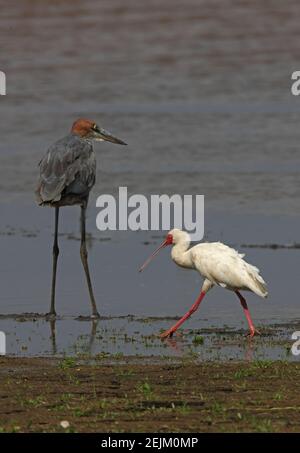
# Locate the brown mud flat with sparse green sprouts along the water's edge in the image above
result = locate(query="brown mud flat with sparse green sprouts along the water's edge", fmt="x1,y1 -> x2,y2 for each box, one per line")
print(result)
0,356 -> 300,432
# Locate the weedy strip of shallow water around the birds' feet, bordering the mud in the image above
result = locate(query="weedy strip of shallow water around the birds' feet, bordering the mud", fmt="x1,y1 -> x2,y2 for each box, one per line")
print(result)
0,314 -> 299,361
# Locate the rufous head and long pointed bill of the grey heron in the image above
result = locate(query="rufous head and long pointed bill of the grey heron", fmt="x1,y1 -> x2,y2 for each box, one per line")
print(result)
71,118 -> 127,145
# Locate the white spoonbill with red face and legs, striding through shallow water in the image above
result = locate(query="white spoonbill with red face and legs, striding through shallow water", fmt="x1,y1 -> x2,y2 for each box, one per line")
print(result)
140,229 -> 268,338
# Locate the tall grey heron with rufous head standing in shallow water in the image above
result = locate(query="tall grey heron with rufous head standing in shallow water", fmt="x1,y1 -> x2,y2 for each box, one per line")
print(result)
36,119 -> 126,318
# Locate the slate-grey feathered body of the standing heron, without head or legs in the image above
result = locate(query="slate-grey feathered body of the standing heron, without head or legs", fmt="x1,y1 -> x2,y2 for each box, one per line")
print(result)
36,132 -> 96,206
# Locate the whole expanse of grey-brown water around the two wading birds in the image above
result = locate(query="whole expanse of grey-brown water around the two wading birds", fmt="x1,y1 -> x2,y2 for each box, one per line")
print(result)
0,0 -> 300,357
